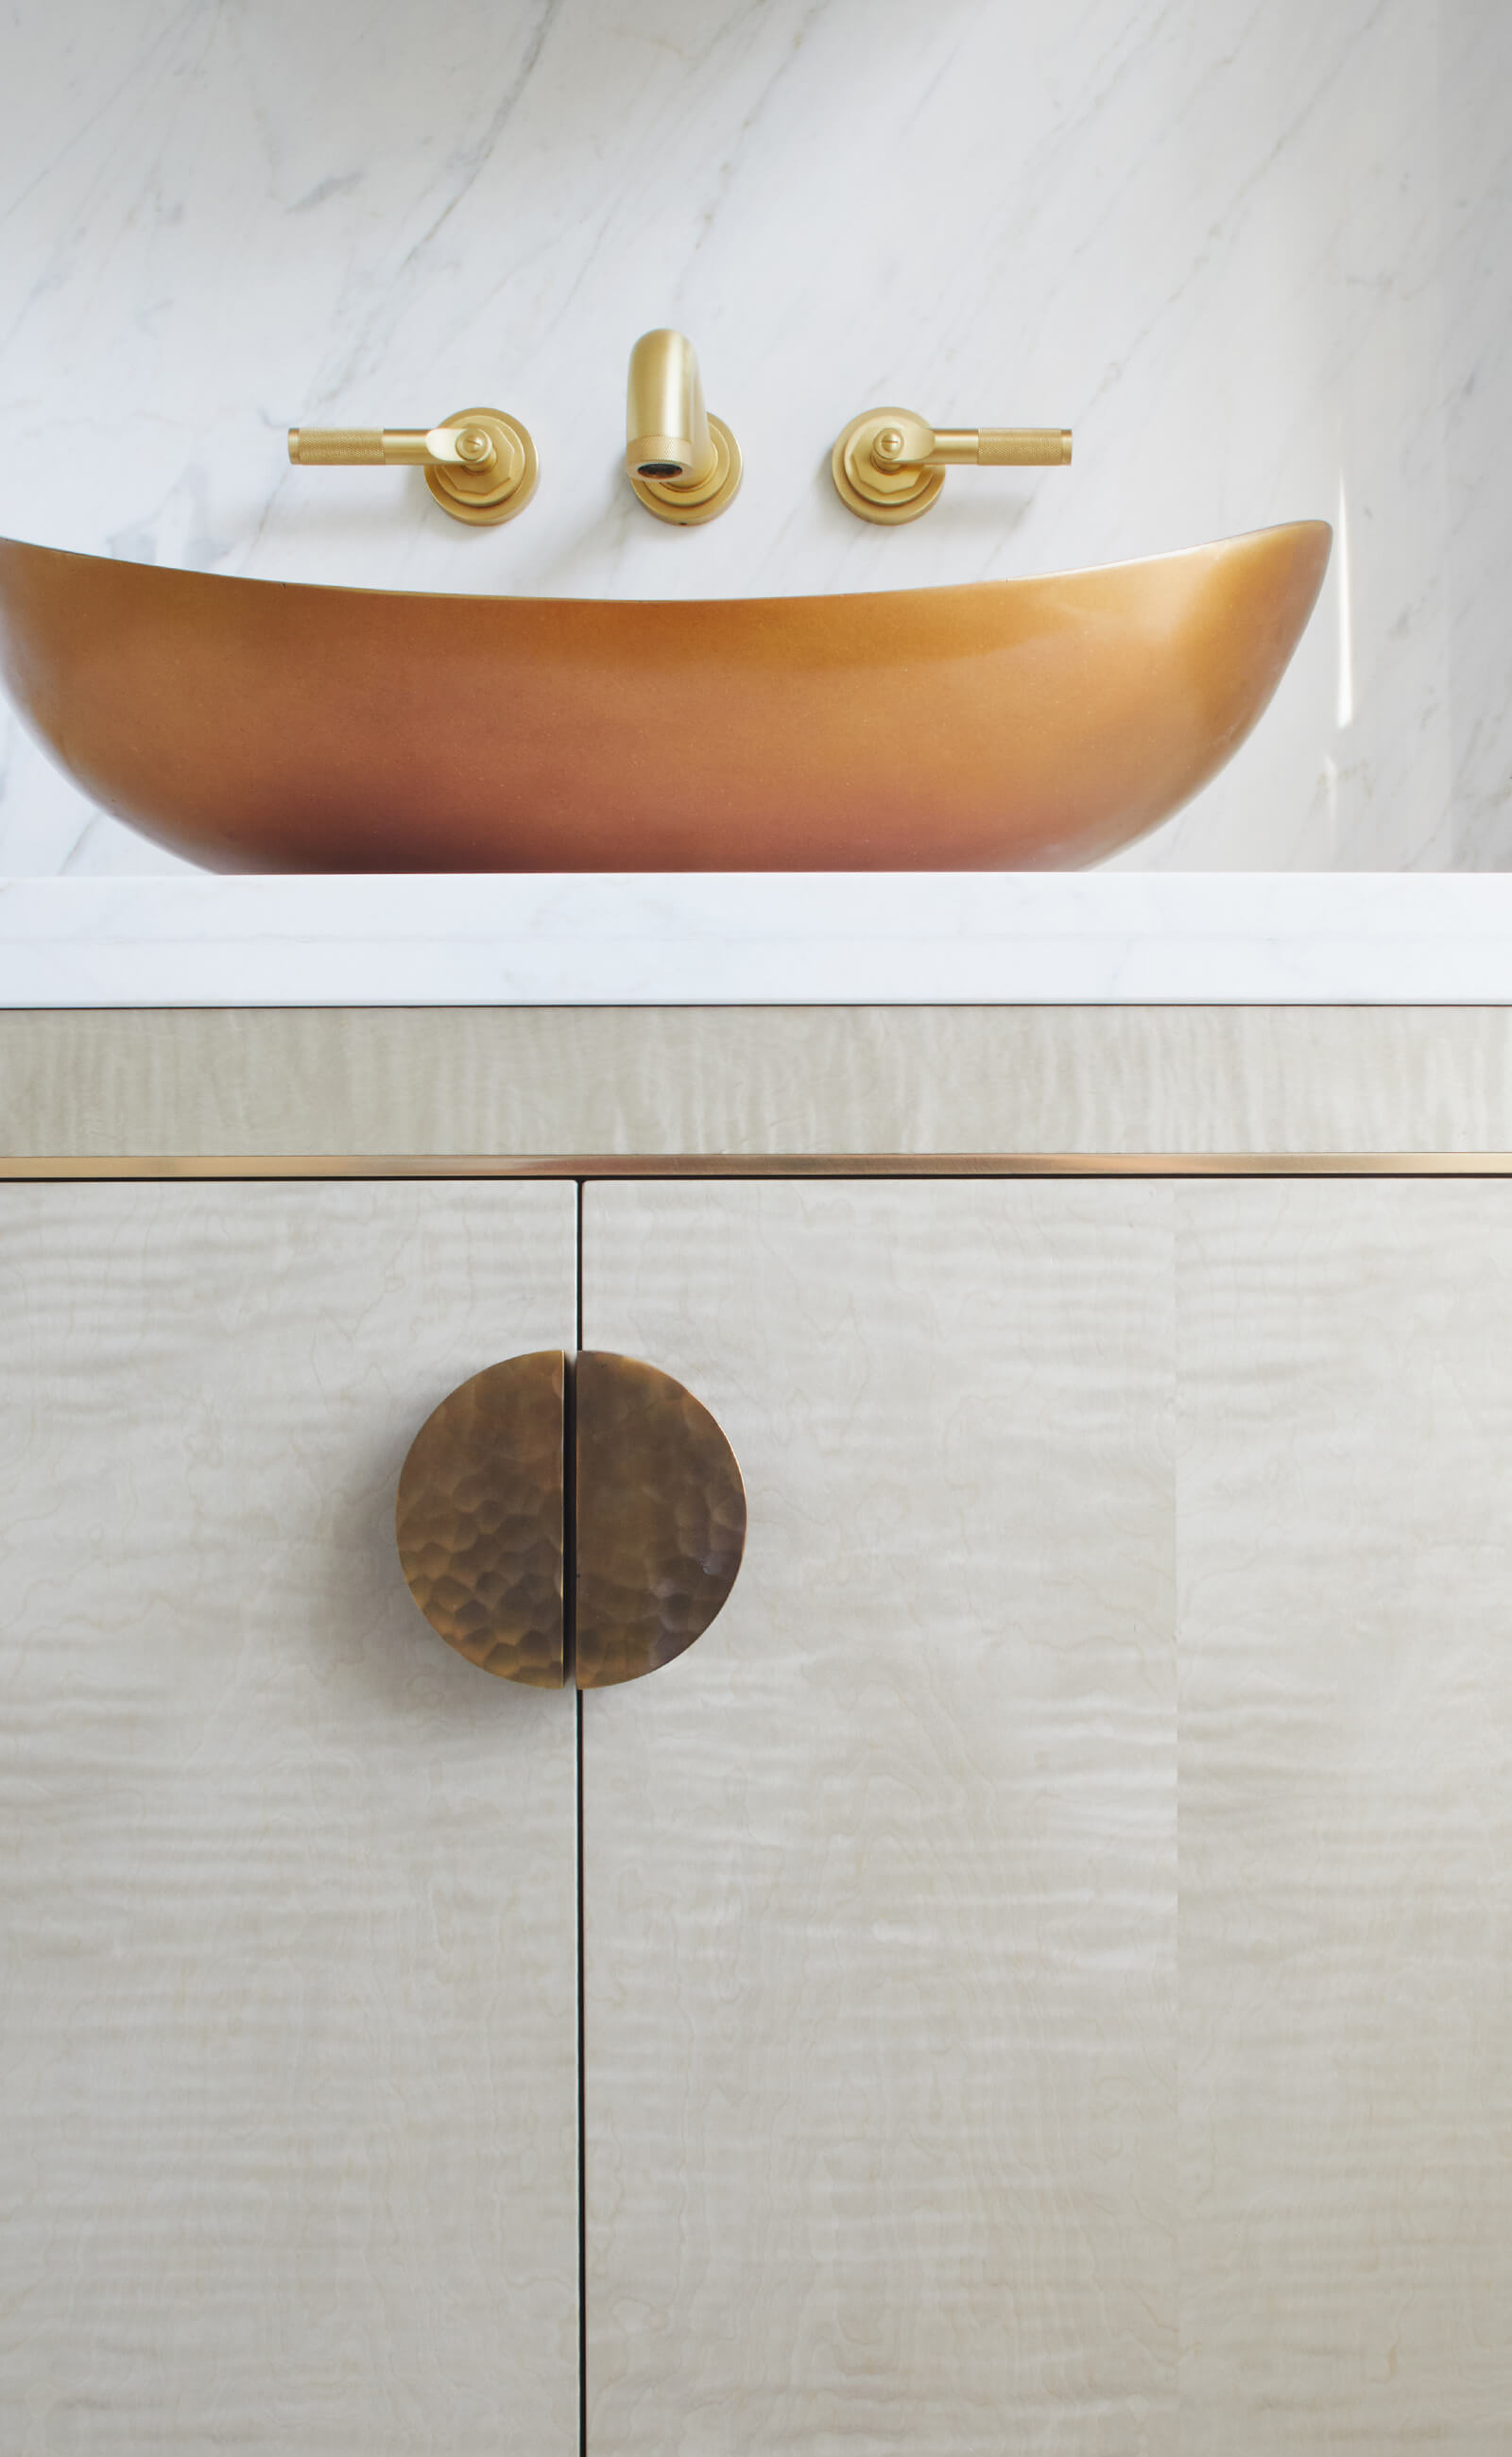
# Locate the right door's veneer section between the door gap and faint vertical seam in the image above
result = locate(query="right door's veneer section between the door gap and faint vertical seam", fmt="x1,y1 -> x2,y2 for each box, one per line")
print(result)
583,1184 -> 1176,2457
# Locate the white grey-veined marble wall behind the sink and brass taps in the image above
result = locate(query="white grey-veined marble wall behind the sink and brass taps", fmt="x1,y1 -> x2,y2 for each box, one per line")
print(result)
0,0 -> 1512,875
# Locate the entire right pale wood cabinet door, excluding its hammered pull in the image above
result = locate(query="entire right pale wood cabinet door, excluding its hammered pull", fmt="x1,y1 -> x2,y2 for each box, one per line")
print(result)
583,1179 -> 1512,2457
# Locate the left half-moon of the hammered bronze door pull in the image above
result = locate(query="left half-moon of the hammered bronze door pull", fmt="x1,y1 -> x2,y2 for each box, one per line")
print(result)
393,1349 -> 565,1688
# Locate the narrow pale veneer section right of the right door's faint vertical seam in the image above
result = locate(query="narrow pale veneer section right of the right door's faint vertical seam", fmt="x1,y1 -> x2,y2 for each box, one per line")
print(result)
1177,1182 -> 1512,2457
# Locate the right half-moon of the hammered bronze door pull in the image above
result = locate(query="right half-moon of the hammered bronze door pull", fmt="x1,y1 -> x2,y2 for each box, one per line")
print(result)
577,1349 -> 745,1688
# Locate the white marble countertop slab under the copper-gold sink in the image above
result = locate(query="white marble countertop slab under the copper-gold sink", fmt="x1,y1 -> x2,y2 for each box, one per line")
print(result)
0,872 -> 1512,1007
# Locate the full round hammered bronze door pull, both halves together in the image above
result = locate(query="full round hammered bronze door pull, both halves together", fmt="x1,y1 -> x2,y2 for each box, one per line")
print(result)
396,1349 -> 745,1688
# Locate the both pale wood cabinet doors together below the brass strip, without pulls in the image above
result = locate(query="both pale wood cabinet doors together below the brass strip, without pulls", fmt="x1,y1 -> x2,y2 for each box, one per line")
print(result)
0,1175 -> 1512,2457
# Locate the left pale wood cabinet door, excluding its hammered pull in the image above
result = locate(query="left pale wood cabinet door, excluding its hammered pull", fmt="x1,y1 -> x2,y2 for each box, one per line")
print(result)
0,1184 -> 577,2457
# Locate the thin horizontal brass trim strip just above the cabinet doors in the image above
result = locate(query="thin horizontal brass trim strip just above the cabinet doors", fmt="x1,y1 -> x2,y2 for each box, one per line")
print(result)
0,1152 -> 1512,1184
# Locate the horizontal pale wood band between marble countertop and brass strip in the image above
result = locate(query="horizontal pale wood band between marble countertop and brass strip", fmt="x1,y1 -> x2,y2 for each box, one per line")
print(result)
0,1007 -> 1512,1155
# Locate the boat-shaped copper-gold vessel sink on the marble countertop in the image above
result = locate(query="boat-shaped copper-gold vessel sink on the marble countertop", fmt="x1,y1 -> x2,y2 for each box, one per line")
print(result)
0,521 -> 1332,869
